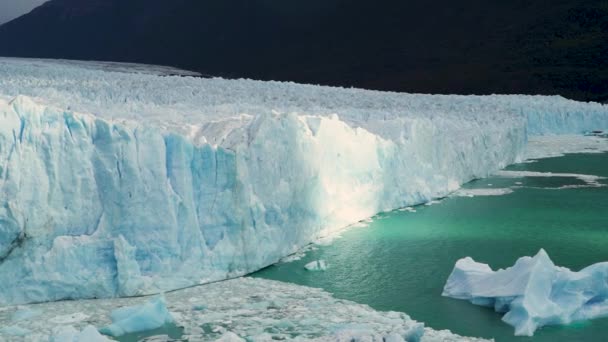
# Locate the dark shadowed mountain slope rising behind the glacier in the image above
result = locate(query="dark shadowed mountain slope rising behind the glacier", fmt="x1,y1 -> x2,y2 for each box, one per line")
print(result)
0,0 -> 608,101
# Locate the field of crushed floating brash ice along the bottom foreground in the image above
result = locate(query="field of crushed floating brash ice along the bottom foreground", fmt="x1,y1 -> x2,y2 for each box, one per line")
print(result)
0,277 -> 485,342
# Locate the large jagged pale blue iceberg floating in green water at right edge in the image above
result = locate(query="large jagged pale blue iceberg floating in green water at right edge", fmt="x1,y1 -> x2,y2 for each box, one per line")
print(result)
443,249 -> 608,336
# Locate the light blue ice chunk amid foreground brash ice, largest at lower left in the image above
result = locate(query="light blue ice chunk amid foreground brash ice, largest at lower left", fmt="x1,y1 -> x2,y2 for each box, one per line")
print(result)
99,296 -> 174,336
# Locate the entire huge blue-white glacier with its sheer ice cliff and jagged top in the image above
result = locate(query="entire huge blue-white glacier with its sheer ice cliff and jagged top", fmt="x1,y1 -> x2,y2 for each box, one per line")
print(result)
0,59 -> 608,305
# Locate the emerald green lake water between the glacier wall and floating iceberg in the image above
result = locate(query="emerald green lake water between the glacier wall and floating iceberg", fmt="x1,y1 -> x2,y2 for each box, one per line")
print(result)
253,154 -> 608,342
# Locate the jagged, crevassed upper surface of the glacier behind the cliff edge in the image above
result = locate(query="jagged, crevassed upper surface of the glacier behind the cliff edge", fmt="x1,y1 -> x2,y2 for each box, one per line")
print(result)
0,58 -> 607,146
